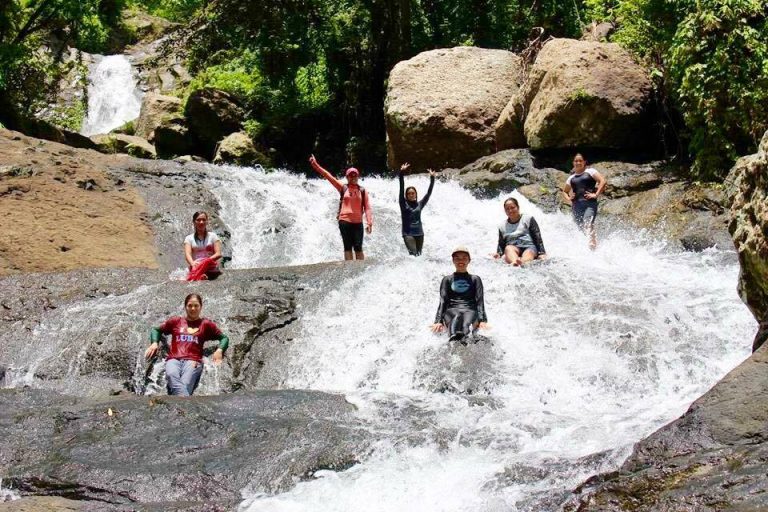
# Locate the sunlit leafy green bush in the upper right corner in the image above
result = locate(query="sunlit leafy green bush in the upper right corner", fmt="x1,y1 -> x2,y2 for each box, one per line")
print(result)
585,0 -> 768,180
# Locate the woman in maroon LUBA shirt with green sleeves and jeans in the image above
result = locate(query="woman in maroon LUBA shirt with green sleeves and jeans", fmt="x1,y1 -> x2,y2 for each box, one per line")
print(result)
144,293 -> 229,396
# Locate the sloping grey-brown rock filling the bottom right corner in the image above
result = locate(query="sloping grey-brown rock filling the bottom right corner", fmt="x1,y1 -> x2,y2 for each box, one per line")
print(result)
565,347 -> 768,512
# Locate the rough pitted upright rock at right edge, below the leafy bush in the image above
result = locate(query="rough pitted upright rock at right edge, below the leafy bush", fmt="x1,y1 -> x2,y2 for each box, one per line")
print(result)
726,132 -> 768,350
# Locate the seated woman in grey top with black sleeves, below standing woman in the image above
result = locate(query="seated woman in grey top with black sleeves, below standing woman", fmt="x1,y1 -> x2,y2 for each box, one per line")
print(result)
493,197 -> 546,267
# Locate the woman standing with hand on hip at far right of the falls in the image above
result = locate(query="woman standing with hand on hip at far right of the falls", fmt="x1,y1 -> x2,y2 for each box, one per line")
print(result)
563,153 -> 606,250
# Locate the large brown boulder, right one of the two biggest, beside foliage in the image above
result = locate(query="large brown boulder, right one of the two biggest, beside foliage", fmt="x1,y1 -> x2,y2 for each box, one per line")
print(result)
496,39 -> 654,149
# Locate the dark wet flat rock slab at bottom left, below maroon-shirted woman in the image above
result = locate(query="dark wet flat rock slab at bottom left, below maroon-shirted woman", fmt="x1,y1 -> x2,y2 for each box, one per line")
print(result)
0,390 -> 369,510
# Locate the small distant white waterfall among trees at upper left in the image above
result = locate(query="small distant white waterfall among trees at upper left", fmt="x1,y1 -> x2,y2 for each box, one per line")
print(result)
80,55 -> 142,135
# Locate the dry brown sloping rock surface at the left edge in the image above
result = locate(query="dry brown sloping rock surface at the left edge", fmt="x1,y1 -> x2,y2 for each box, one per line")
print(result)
0,129 -> 157,278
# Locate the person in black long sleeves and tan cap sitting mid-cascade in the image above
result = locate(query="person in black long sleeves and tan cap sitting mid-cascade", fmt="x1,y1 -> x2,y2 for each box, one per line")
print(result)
432,246 -> 488,341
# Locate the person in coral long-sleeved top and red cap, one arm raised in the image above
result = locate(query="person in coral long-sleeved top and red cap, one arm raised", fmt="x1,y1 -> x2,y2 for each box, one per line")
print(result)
309,155 -> 373,260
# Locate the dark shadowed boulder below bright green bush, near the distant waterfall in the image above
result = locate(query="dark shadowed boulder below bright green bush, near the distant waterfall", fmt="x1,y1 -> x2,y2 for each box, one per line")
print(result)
184,88 -> 244,159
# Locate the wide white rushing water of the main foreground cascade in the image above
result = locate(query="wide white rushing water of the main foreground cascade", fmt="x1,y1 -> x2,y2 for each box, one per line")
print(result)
204,168 -> 755,512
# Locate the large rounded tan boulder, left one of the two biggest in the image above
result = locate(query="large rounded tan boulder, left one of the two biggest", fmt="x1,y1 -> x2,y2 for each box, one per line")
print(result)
385,47 -> 521,170
